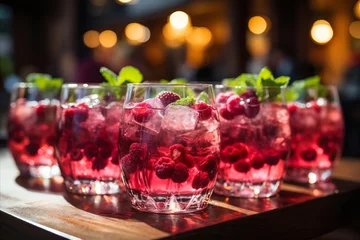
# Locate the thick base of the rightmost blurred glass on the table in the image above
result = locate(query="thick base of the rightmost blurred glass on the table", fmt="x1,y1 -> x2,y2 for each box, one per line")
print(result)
285,167 -> 332,184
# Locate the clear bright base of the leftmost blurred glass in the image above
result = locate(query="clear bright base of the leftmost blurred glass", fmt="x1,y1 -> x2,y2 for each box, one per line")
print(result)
16,162 -> 61,178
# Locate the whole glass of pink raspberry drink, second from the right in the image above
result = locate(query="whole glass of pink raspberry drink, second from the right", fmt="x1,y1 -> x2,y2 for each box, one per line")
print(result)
215,85 -> 290,198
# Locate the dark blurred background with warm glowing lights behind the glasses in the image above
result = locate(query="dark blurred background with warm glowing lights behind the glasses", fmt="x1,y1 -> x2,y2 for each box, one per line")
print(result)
0,0 -> 360,157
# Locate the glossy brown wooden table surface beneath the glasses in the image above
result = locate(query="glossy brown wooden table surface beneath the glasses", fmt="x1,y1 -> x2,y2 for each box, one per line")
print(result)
0,149 -> 360,239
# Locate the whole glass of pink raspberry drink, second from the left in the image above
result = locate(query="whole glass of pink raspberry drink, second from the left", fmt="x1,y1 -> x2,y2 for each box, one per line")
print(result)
57,84 -> 126,195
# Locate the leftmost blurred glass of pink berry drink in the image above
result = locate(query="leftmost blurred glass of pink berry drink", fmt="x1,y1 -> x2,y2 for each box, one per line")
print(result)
8,82 -> 60,178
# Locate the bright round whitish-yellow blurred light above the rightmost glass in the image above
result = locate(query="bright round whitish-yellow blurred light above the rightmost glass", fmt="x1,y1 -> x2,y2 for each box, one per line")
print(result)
310,20 -> 334,44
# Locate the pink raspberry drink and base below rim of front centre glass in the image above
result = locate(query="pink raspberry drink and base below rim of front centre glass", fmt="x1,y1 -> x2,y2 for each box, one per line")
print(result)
119,106 -> 219,213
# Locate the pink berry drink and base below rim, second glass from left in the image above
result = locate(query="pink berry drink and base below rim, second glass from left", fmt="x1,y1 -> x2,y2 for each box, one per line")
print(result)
57,103 -> 122,194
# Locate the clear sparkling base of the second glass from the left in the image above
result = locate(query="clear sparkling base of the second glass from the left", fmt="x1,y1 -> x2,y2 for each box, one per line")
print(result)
64,179 -> 121,195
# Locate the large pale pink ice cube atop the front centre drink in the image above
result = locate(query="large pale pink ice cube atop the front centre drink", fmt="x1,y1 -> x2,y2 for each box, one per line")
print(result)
161,105 -> 199,131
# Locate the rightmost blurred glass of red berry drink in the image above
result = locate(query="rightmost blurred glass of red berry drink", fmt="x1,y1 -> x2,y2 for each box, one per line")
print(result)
286,86 -> 344,184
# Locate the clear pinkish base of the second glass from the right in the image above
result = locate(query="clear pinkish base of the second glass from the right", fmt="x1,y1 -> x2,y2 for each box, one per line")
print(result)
214,179 -> 281,198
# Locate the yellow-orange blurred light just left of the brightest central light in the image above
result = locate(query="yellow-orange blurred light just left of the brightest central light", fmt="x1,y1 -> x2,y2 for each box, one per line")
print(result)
125,23 -> 150,45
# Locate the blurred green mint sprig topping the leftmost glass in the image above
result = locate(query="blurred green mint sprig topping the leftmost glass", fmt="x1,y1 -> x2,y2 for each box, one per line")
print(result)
26,73 -> 63,98
